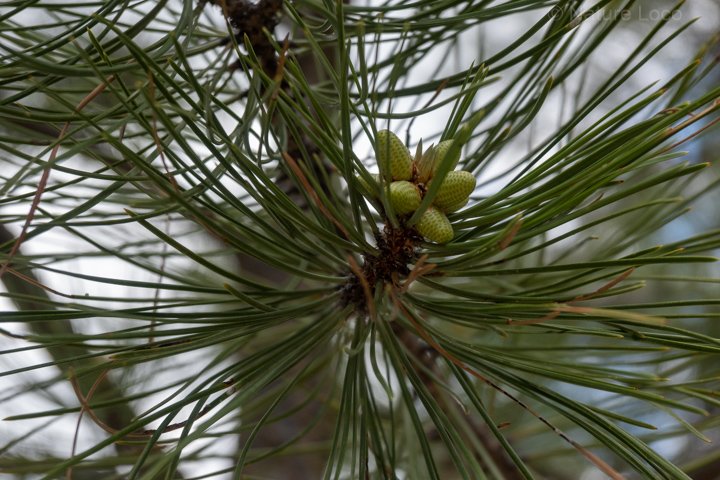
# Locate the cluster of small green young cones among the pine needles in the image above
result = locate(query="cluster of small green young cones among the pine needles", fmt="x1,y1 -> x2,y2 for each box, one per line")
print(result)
361,130 -> 475,243
